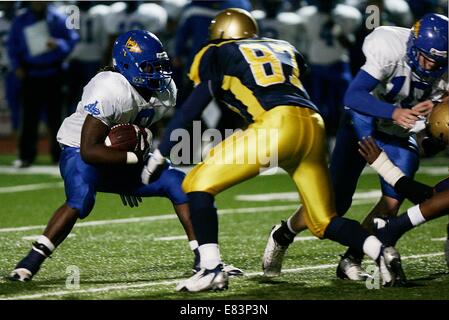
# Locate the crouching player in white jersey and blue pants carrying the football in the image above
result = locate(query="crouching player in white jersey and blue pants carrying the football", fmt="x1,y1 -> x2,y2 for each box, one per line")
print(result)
10,30 -> 242,281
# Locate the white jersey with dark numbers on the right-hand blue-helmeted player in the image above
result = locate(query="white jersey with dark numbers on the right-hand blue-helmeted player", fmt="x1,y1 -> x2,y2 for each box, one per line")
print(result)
362,27 -> 449,136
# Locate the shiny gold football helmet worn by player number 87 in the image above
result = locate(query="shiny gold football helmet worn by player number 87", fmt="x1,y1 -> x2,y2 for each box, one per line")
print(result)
209,8 -> 259,41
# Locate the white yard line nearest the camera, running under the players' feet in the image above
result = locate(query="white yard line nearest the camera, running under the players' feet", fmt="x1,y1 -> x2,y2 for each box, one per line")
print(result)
0,252 -> 444,300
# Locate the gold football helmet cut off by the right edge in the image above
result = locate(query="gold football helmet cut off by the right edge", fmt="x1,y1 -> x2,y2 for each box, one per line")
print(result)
427,102 -> 449,145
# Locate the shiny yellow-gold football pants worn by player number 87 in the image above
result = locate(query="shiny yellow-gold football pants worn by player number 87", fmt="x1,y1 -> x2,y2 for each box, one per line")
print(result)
183,106 -> 336,238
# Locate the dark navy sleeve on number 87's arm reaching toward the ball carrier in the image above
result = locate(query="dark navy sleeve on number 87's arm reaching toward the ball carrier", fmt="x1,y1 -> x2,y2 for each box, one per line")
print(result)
159,82 -> 212,157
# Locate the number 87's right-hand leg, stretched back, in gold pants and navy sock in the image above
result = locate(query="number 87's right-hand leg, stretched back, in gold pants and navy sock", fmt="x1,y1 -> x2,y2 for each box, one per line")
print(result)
265,111 -> 404,284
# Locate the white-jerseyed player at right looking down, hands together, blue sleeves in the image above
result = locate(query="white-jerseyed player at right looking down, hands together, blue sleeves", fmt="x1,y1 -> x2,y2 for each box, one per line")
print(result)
264,14 -> 448,280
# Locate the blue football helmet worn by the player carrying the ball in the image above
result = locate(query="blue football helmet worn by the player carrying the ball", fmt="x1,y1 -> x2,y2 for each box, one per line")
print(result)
112,30 -> 172,91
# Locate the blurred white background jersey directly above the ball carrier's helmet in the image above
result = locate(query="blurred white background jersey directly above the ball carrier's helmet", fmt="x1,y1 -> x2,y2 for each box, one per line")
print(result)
106,3 -> 168,35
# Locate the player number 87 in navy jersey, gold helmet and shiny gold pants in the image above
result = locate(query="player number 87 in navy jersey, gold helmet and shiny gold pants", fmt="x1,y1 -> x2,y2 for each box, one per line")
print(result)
142,8 -> 403,292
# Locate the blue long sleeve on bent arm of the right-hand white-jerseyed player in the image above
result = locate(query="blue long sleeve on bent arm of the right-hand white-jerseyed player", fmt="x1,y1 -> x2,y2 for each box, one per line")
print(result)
344,70 -> 396,119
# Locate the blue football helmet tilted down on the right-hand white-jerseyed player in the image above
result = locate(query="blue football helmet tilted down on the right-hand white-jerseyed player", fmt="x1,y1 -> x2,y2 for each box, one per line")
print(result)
407,13 -> 449,80
